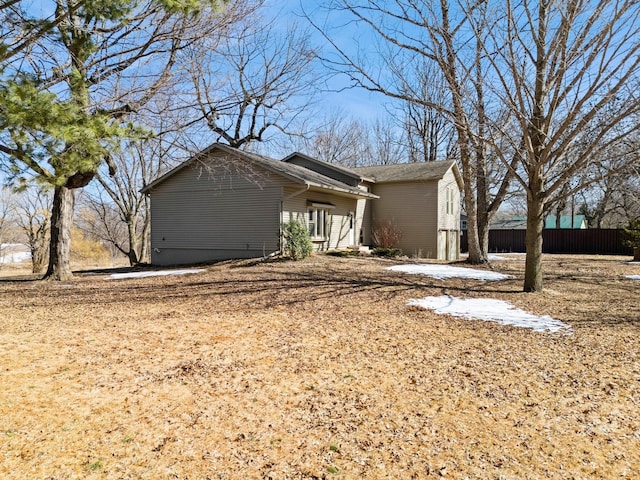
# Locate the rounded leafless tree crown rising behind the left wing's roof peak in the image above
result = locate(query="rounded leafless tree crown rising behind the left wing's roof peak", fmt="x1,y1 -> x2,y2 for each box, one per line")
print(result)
187,9 -> 321,148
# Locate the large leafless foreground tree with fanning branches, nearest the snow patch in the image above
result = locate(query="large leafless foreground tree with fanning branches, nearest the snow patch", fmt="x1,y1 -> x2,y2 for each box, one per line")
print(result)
477,0 -> 640,292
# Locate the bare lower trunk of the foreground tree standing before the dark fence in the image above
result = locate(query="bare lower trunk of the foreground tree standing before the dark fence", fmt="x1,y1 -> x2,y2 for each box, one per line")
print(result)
523,189 -> 544,292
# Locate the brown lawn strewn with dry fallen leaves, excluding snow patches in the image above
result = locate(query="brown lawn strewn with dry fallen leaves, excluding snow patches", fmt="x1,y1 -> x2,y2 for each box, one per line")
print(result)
0,255 -> 640,480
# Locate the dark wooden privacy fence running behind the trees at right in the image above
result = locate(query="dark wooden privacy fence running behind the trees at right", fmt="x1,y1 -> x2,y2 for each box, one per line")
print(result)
460,228 -> 633,255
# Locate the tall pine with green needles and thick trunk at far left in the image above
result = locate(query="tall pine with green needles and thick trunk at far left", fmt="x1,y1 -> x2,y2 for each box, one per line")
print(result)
0,0 -> 234,280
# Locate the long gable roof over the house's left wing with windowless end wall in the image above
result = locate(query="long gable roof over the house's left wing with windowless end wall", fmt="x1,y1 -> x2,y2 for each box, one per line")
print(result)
140,143 -> 378,198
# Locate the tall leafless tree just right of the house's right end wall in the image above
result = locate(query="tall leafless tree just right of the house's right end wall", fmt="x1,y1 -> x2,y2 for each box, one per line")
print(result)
307,0 -> 519,263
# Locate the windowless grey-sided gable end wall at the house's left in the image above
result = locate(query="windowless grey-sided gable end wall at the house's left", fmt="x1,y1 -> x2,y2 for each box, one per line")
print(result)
151,157 -> 283,265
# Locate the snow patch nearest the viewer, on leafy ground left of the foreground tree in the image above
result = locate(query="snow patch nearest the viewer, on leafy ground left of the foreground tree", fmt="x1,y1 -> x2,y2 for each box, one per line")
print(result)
408,295 -> 571,332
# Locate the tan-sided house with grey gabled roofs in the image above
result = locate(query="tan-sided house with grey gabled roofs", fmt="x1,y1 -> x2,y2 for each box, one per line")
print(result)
142,144 -> 462,265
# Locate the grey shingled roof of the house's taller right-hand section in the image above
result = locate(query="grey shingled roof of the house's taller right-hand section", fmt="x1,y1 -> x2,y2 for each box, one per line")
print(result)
353,160 -> 462,187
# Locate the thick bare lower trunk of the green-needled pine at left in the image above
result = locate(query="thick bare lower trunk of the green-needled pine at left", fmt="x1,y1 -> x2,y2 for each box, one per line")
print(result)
43,186 -> 75,280
